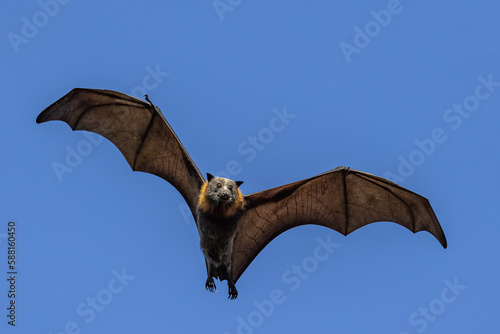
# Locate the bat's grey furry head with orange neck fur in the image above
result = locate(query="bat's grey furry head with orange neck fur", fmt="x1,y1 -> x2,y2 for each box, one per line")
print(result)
198,173 -> 243,217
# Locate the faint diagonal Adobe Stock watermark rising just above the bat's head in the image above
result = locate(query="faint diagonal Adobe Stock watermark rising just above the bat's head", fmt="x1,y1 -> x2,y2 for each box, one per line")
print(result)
178,106 -> 297,224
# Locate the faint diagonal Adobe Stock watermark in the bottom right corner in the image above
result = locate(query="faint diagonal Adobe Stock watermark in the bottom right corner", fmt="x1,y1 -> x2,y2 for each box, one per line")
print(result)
399,277 -> 467,334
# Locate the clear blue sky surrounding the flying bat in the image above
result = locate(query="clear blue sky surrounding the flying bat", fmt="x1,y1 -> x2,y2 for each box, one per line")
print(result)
0,0 -> 500,334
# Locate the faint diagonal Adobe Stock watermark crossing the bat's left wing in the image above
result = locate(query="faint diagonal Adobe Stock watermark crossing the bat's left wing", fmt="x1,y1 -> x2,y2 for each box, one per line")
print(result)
51,64 -> 170,182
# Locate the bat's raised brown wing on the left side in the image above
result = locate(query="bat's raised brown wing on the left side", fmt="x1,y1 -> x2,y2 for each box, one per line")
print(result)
36,88 -> 204,219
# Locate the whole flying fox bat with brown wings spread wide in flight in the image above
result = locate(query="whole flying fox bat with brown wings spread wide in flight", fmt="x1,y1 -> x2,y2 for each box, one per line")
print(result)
36,88 -> 447,299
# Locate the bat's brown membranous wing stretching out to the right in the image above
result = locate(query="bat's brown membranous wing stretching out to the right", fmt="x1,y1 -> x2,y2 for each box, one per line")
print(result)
231,167 -> 446,282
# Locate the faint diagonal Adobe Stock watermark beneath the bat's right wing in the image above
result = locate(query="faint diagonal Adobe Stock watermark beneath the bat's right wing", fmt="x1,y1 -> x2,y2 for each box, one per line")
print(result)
224,235 -> 340,334
